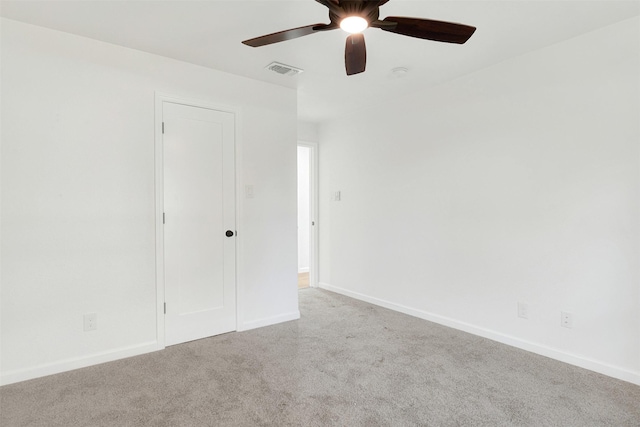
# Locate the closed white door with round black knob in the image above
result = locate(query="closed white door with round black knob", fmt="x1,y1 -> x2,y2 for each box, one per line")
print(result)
162,102 -> 236,345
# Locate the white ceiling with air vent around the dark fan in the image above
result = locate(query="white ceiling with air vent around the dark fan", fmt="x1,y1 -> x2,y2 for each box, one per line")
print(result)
0,0 -> 640,122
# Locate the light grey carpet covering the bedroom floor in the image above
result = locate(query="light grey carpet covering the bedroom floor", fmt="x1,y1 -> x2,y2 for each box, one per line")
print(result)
0,289 -> 640,427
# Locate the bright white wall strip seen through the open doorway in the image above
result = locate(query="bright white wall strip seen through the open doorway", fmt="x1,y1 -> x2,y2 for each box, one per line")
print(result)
298,146 -> 311,273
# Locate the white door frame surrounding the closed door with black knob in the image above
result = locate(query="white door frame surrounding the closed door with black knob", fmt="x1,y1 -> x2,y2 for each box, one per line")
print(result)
154,91 -> 242,350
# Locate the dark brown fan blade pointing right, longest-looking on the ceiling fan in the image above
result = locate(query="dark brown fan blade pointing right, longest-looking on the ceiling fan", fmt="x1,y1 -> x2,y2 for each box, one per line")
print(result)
380,16 -> 476,44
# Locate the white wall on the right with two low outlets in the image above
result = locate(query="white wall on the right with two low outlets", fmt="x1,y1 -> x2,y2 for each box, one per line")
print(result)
320,18 -> 640,384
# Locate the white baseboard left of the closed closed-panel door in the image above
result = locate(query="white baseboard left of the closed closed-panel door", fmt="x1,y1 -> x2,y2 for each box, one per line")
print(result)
0,341 -> 164,385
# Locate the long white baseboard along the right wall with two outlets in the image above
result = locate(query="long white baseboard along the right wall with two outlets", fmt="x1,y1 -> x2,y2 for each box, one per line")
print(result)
318,283 -> 640,385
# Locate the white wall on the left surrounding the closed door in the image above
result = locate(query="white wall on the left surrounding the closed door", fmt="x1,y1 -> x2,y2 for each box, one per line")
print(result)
0,20 -> 299,383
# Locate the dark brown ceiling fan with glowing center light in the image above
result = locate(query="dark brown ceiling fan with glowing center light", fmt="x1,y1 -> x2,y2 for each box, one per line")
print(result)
242,0 -> 476,76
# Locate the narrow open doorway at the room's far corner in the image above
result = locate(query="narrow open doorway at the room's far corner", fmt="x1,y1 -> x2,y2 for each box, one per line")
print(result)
298,142 -> 318,289
